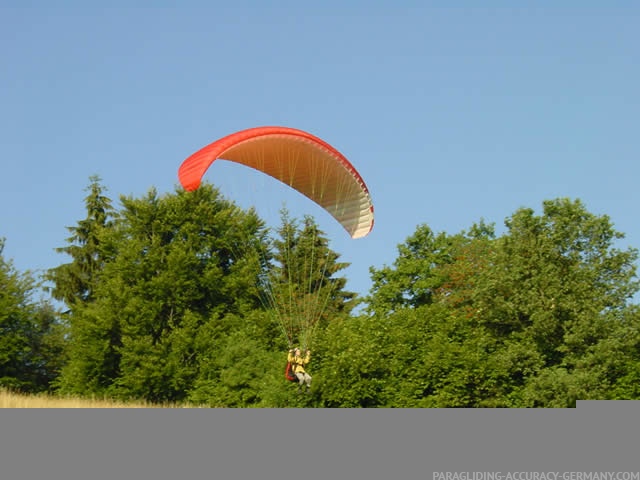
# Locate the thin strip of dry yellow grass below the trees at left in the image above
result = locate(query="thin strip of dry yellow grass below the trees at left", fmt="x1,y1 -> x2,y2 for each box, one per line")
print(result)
0,390 -> 184,408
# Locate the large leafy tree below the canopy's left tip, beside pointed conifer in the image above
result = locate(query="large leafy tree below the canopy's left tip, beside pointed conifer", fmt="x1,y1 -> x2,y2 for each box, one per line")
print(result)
55,186 -> 272,401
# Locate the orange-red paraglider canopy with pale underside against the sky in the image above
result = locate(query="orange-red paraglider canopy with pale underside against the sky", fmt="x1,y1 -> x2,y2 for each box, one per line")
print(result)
178,127 -> 373,238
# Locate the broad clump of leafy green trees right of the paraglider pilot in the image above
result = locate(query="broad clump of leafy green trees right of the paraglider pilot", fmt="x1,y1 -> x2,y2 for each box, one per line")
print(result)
358,199 -> 640,407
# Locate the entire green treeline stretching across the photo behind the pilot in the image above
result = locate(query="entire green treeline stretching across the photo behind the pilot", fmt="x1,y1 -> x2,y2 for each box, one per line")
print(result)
0,177 -> 640,407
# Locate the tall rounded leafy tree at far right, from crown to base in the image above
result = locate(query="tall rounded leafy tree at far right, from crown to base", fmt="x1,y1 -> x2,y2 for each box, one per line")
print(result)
448,198 -> 638,407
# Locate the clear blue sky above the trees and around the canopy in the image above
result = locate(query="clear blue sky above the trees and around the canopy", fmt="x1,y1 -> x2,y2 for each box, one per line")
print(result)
0,1 -> 640,302
